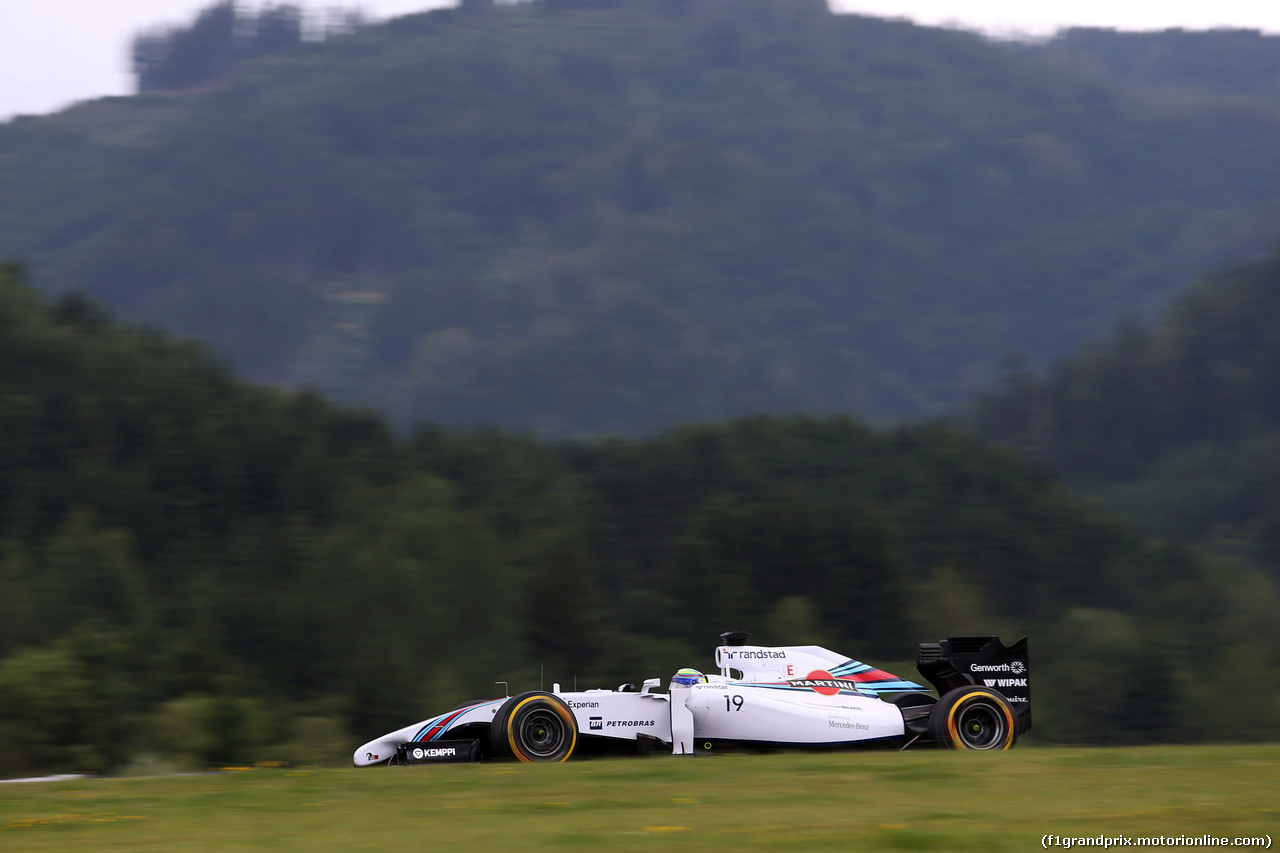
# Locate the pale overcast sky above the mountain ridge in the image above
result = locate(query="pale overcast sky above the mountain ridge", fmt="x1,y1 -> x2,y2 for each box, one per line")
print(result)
0,0 -> 1280,122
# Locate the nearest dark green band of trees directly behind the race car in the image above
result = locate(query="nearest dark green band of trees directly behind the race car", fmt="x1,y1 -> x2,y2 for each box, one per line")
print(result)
0,266 -> 1280,774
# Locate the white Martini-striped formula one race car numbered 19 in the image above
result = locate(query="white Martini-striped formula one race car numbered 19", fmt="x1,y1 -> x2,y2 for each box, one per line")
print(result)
355,631 -> 1032,767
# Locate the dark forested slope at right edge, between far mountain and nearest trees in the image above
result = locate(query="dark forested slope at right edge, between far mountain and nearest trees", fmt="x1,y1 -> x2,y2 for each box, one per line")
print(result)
972,247 -> 1280,568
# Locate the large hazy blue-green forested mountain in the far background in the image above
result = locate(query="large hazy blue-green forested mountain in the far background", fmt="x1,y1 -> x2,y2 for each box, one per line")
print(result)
0,0 -> 1280,427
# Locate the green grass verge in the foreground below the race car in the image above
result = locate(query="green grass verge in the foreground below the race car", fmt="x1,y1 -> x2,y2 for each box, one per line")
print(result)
0,744 -> 1280,853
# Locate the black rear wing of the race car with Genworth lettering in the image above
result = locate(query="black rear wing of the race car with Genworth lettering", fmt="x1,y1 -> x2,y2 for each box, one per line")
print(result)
915,637 -> 1032,734
